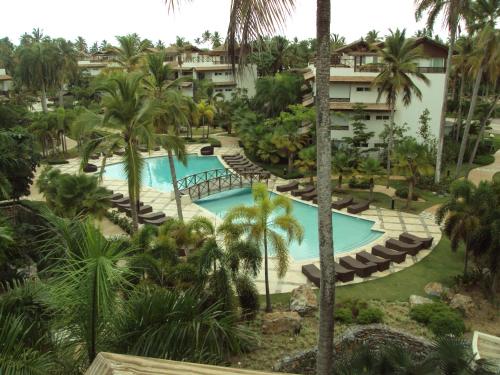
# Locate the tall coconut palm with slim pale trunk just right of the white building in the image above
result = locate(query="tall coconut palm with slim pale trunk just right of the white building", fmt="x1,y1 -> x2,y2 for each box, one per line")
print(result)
415,0 -> 471,183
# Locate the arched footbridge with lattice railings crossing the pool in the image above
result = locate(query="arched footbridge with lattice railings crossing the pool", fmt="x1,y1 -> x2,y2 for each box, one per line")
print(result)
177,168 -> 271,200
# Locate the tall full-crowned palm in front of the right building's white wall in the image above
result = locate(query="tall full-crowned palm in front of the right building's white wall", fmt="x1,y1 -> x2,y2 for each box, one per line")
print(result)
373,29 -> 429,187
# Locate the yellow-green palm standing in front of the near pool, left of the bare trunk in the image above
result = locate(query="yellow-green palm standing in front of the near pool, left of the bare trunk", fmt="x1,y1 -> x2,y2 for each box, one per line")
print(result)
222,184 -> 304,312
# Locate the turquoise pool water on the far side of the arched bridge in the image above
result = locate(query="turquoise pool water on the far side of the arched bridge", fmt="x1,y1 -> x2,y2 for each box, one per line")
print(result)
104,155 -> 224,191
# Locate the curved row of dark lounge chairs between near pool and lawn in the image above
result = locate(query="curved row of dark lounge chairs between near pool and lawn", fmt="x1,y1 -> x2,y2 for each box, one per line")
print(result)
302,232 -> 433,288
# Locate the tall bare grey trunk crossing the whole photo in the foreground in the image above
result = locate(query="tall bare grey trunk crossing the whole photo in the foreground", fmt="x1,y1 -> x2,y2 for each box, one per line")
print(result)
316,0 -> 335,375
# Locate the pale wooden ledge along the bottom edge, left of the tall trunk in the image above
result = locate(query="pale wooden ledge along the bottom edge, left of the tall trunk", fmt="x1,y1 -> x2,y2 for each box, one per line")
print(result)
85,352 -> 292,375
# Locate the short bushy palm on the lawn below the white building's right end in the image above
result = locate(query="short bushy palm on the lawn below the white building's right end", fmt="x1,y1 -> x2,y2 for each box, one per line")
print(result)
394,138 -> 433,208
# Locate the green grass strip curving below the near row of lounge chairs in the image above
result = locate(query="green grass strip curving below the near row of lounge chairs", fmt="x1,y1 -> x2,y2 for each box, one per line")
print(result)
262,237 -> 464,305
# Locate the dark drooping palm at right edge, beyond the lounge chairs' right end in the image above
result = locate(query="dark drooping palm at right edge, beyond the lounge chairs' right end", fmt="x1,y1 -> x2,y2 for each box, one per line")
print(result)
436,180 -> 496,275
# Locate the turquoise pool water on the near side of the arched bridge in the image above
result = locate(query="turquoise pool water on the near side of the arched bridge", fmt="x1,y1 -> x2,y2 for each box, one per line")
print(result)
196,189 -> 382,260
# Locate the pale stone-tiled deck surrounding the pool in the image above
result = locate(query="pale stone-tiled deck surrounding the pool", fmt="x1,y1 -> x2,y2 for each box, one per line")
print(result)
40,144 -> 441,294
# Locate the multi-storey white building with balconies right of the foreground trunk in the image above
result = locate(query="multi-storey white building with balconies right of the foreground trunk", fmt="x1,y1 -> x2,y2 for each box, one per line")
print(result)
303,37 -> 448,148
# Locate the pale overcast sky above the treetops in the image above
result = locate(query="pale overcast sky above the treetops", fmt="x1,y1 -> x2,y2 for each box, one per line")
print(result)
0,0 -> 446,45
